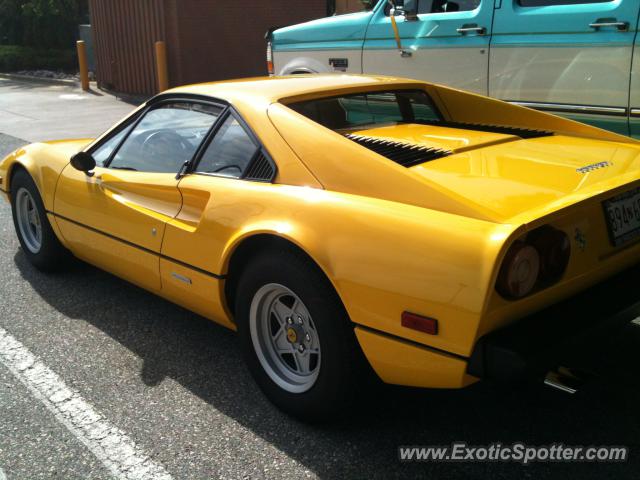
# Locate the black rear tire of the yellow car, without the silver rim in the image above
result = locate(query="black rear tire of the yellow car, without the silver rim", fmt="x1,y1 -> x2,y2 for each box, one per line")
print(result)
235,249 -> 371,422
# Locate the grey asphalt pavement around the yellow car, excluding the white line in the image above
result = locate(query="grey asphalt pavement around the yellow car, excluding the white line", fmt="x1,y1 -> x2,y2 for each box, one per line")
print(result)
0,77 -> 640,480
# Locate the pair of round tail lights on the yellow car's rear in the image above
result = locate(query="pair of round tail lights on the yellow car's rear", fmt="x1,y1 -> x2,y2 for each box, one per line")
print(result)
496,225 -> 571,299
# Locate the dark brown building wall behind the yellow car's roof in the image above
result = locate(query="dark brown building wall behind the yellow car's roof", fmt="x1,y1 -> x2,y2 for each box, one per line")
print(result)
90,0 -> 327,94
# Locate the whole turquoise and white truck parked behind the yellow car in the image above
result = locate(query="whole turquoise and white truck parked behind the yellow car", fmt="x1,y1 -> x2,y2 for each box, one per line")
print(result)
267,0 -> 640,137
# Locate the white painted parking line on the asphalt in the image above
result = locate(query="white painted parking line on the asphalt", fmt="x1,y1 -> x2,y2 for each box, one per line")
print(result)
0,328 -> 172,480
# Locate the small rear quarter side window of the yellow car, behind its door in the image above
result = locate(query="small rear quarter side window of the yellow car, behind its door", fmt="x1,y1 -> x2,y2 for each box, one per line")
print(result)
196,115 -> 258,178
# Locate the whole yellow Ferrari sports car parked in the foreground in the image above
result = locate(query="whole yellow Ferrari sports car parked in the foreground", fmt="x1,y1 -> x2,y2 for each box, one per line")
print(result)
0,75 -> 640,419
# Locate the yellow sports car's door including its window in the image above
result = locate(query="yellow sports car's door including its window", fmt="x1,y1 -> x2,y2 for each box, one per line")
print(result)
54,99 -> 222,290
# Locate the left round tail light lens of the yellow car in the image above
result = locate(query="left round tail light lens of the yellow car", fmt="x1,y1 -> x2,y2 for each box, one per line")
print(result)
496,240 -> 540,298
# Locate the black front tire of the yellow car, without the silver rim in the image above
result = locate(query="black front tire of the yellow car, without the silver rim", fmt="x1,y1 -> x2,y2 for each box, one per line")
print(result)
11,169 -> 69,272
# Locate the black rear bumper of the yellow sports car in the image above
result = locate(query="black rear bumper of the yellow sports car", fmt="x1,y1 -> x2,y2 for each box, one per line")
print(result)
467,265 -> 640,382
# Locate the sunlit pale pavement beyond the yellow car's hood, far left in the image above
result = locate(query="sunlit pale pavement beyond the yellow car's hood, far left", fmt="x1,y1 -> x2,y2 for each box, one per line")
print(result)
0,78 -> 145,142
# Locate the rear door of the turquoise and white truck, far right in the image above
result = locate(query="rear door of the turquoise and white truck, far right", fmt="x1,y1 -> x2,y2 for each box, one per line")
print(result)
489,0 -> 640,135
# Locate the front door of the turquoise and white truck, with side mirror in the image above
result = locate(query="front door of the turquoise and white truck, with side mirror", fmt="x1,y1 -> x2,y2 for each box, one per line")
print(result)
362,0 -> 494,95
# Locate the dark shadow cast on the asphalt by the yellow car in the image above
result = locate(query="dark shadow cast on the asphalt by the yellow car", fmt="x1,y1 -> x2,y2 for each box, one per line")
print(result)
14,250 -> 640,479
